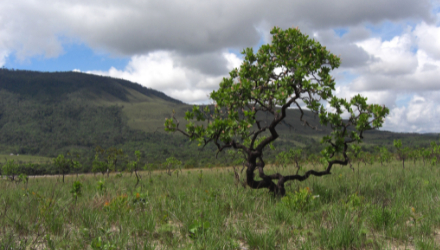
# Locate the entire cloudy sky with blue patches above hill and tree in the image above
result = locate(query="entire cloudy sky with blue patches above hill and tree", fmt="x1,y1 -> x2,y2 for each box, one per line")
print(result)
0,0 -> 440,133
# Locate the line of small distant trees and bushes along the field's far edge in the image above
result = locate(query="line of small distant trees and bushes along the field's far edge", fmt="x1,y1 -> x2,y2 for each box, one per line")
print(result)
0,140 -> 440,180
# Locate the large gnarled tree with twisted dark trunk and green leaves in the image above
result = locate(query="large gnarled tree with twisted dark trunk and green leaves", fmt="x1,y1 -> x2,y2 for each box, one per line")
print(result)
165,27 -> 389,196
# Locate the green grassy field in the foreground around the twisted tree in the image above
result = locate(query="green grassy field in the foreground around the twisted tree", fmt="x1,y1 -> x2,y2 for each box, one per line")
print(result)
0,162 -> 440,249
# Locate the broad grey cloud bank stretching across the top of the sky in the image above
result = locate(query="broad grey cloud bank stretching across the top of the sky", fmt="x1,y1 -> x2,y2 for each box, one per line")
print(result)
0,0 -> 434,60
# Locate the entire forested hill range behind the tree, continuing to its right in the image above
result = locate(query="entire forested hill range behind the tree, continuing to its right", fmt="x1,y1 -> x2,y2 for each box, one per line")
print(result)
0,69 -> 436,166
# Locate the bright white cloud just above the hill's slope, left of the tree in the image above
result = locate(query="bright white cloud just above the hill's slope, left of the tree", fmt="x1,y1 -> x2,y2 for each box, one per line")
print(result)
87,51 -> 241,103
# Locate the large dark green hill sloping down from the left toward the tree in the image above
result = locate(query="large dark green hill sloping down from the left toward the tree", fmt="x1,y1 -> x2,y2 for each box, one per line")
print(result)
0,69 -> 194,160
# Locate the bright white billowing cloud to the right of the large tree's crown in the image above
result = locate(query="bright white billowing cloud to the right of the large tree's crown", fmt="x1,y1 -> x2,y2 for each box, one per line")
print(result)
330,23 -> 440,132
